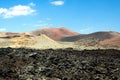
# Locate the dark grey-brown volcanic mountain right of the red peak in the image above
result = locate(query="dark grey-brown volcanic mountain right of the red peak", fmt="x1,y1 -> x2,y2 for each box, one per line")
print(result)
61,31 -> 120,41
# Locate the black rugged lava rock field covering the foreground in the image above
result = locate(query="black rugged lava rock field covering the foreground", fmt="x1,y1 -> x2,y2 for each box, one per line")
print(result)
0,48 -> 120,80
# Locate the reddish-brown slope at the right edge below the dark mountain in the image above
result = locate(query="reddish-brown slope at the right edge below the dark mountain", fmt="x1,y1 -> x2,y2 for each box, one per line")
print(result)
100,36 -> 120,46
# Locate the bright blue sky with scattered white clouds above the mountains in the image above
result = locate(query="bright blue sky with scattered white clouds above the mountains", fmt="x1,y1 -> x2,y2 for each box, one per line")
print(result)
0,0 -> 120,34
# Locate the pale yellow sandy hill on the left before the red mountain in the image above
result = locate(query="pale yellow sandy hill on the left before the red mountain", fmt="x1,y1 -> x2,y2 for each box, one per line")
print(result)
0,33 -> 64,49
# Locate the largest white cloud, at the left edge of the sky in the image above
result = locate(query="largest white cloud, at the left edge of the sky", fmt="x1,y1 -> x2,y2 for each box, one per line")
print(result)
0,5 -> 35,18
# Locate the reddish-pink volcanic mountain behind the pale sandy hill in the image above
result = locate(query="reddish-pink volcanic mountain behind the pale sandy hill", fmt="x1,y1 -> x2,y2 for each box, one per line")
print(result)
30,28 -> 78,40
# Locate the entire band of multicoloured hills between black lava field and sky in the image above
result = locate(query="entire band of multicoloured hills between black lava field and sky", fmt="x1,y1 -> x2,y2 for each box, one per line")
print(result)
0,28 -> 120,49
